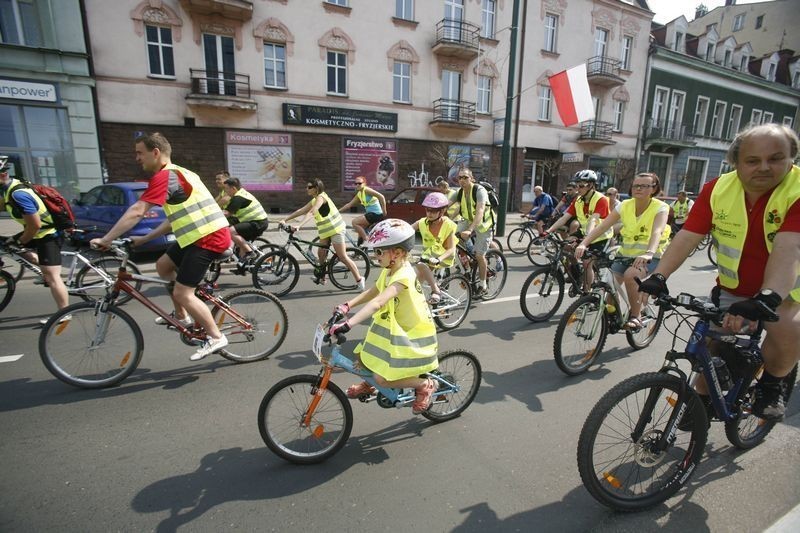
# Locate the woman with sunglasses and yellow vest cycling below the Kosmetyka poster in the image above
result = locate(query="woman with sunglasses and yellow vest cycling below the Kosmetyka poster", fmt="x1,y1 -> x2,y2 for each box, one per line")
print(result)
281,178 -> 365,290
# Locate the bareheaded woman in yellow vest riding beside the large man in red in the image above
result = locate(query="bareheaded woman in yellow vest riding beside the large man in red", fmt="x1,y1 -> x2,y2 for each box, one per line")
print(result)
575,172 -> 670,329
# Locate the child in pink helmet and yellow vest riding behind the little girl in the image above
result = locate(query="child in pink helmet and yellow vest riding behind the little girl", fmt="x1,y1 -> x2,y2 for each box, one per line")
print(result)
411,192 -> 458,305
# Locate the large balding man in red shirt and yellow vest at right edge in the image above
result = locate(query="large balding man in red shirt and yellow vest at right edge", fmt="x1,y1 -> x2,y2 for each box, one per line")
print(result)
640,124 -> 800,420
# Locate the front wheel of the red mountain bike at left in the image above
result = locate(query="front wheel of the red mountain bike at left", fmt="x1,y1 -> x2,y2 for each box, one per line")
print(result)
39,302 -> 144,389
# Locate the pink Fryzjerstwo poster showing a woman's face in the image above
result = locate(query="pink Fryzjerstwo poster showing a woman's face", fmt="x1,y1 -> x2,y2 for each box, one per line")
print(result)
342,137 -> 397,191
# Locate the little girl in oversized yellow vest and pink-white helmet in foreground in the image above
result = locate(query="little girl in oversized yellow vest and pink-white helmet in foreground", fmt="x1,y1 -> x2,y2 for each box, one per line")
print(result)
329,218 -> 439,415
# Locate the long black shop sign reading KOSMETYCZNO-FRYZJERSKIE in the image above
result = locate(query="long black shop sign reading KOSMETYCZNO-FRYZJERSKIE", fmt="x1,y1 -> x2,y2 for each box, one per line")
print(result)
283,103 -> 397,132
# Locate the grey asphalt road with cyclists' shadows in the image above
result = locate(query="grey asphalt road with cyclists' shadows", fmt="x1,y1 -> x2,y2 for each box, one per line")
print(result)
0,222 -> 800,532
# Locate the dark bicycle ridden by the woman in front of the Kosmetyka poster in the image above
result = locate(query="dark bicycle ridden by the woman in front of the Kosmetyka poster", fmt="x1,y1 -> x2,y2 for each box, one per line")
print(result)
253,224 -> 370,296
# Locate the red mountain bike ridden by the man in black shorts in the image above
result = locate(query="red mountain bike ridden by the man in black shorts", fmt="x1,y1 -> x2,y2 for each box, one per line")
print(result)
39,239 -> 289,389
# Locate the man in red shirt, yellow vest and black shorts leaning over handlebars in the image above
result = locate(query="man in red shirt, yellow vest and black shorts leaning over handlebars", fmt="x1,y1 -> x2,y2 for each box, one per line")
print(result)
91,133 -> 231,361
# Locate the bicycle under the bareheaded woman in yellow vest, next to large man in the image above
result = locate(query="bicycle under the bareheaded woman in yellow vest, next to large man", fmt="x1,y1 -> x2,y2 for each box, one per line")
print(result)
553,246 -> 664,376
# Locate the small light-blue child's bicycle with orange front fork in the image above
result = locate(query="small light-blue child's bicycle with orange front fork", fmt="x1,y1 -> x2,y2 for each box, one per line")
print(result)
258,313 -> 481,464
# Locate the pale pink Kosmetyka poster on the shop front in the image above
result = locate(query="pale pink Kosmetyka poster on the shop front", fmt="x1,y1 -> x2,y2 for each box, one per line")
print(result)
225,131 -> 294,192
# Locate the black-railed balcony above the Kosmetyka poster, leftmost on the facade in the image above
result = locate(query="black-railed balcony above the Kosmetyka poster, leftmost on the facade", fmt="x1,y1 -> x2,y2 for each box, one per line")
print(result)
186,68 -> 258,111
